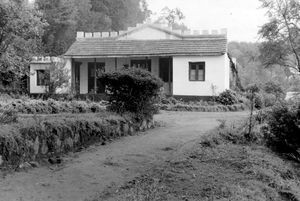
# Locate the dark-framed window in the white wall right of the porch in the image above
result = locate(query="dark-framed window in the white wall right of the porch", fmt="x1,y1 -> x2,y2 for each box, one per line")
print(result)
189,62 -> 205,81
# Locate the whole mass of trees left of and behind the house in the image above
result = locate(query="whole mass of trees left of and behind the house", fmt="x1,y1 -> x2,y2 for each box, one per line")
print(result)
0,0 -> 150,87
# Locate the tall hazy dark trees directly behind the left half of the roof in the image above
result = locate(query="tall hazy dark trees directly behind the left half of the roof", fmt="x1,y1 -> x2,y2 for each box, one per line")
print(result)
36,0 -> 149,56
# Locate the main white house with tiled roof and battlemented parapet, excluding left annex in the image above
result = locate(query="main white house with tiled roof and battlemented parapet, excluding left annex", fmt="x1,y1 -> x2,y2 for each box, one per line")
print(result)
64,24 -> 230,96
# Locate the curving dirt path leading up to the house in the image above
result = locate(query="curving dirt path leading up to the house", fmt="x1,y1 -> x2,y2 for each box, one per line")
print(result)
0,112 -> 247,201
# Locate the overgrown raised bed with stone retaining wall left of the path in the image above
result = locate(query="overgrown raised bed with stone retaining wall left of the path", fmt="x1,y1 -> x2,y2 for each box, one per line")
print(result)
0,112 -> 154,169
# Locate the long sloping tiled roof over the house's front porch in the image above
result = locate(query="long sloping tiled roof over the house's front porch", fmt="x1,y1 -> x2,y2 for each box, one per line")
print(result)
65,37 -> 227,57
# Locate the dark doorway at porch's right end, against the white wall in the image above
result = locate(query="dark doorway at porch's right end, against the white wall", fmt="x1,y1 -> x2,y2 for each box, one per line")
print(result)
159,57 -> 173,95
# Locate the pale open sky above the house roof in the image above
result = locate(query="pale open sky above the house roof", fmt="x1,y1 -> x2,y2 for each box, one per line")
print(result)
146,0 -> 268,42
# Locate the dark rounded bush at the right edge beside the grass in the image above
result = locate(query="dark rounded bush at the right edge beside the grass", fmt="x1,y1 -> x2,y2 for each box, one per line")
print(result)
265,103 -> 300,161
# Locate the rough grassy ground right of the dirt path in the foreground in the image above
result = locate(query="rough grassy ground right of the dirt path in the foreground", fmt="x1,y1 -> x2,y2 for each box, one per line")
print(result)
93,119 -> 300,201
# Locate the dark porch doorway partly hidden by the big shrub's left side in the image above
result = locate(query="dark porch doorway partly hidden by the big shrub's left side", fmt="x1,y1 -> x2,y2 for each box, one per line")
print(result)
88,62 -> 105,93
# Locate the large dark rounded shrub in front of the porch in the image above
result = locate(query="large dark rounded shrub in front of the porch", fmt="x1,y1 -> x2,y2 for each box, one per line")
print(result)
100,68 -> 163,118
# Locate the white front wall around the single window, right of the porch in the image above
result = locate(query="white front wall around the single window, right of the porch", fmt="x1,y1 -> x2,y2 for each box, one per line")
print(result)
173,55 -> 229,96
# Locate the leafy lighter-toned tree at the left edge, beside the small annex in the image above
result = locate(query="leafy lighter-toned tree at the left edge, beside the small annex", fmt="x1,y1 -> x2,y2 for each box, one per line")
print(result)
0,0 -> 47,85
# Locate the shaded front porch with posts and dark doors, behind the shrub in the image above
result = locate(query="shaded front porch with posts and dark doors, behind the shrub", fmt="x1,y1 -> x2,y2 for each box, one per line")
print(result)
71,56 -> 173,95
